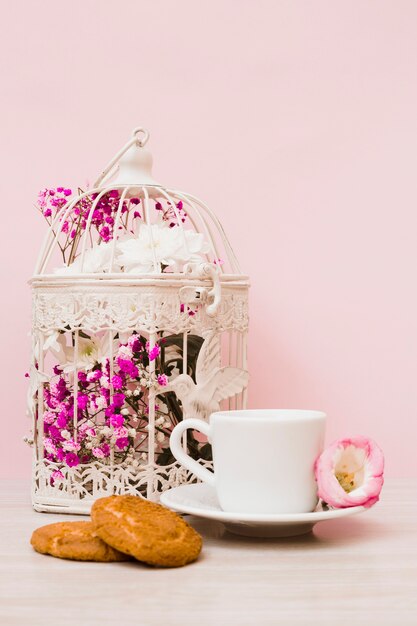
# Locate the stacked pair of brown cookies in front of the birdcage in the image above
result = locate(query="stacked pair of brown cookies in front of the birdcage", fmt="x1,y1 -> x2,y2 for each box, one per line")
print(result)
31,496 -> 202,567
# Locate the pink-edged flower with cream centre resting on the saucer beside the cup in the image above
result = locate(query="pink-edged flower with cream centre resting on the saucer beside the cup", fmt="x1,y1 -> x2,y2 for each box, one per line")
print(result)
314,437 -> 384,508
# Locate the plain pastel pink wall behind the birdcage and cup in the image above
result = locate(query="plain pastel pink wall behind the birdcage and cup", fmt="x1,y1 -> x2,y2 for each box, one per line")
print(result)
0,0 -> 417,476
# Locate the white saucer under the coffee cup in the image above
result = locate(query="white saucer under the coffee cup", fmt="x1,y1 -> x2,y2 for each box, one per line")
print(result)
160,483 -> 366,537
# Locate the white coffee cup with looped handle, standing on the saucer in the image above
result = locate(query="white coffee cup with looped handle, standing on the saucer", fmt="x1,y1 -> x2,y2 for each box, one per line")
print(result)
170,409 -> 326,514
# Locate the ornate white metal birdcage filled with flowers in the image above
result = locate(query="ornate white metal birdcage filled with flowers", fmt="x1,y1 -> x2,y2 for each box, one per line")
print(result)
28,128 -> 248,513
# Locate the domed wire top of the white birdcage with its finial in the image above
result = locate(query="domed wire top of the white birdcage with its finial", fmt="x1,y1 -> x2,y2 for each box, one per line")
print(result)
32,128 -> 247,284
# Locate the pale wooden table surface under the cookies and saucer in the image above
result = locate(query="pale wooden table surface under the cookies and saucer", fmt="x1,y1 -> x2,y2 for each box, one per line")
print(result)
0,480 -> 417,626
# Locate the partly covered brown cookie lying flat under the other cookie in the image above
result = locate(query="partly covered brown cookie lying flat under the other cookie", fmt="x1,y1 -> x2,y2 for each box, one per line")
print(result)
30,522 -> 129,562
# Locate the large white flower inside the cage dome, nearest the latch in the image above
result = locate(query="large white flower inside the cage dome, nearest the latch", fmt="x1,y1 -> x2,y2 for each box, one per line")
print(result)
117,224 -> 208,274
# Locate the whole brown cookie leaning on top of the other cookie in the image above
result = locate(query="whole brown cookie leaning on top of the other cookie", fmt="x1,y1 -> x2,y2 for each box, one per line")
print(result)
91,496 -> 202,567
